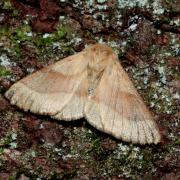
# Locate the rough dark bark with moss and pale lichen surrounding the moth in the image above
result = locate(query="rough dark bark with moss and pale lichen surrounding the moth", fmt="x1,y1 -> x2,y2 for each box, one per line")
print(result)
0,0 -> 180,180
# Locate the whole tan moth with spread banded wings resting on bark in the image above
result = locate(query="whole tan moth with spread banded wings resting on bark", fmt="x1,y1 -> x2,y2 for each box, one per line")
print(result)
5,44 -> 161,144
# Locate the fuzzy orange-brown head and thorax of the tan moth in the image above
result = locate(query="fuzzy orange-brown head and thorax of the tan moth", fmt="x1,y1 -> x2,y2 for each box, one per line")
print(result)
87,44 -> 117,71
